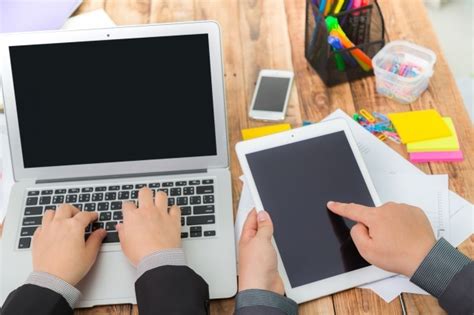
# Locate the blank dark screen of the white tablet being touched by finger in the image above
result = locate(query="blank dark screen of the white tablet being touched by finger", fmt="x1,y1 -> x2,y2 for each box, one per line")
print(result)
246,131 -> 374,288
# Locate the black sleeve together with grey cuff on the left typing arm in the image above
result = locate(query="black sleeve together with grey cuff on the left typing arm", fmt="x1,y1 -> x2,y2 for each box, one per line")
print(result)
2,272 -> 80,315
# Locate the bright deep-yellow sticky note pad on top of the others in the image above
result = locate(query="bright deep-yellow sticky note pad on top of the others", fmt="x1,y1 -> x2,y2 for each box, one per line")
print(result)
388,109 -> 451,143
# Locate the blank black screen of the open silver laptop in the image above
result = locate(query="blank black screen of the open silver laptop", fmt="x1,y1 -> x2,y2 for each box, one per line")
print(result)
10,34 -> 217,168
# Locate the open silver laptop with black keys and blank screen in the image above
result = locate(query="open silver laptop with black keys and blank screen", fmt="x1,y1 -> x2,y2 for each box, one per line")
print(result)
0,22 -> 237,307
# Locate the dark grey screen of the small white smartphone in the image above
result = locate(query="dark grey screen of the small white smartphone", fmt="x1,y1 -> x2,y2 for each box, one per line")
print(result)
253,76 -> 290,112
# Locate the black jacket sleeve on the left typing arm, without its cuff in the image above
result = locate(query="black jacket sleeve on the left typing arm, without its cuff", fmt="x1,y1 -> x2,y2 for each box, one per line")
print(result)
0,284 -> 72,315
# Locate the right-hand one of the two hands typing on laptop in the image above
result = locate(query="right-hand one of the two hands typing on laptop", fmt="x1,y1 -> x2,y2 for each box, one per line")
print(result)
116,188 -> 181,266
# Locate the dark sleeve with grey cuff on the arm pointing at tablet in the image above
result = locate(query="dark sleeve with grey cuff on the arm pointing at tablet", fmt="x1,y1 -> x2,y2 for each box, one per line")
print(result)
410,238 -> 474,314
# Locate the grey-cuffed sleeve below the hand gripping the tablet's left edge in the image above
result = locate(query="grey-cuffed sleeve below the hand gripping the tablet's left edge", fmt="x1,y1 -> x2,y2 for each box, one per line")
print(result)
235,289 -> 298,315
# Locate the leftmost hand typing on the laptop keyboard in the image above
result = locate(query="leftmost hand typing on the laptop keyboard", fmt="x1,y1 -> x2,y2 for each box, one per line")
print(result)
32,204 -> 107,285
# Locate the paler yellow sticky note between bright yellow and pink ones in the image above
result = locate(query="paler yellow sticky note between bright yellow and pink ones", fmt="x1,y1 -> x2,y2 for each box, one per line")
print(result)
407,117 -> 459,152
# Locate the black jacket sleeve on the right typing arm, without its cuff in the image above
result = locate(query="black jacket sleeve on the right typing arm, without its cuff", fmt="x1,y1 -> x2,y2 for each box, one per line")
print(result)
135,265 -> 209,315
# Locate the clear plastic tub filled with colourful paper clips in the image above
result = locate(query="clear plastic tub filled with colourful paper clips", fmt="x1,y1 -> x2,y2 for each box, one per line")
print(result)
372,40 -> 436,104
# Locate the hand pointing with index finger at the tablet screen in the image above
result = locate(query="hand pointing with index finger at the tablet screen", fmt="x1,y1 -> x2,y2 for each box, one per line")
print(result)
327,201 -> 436,277
